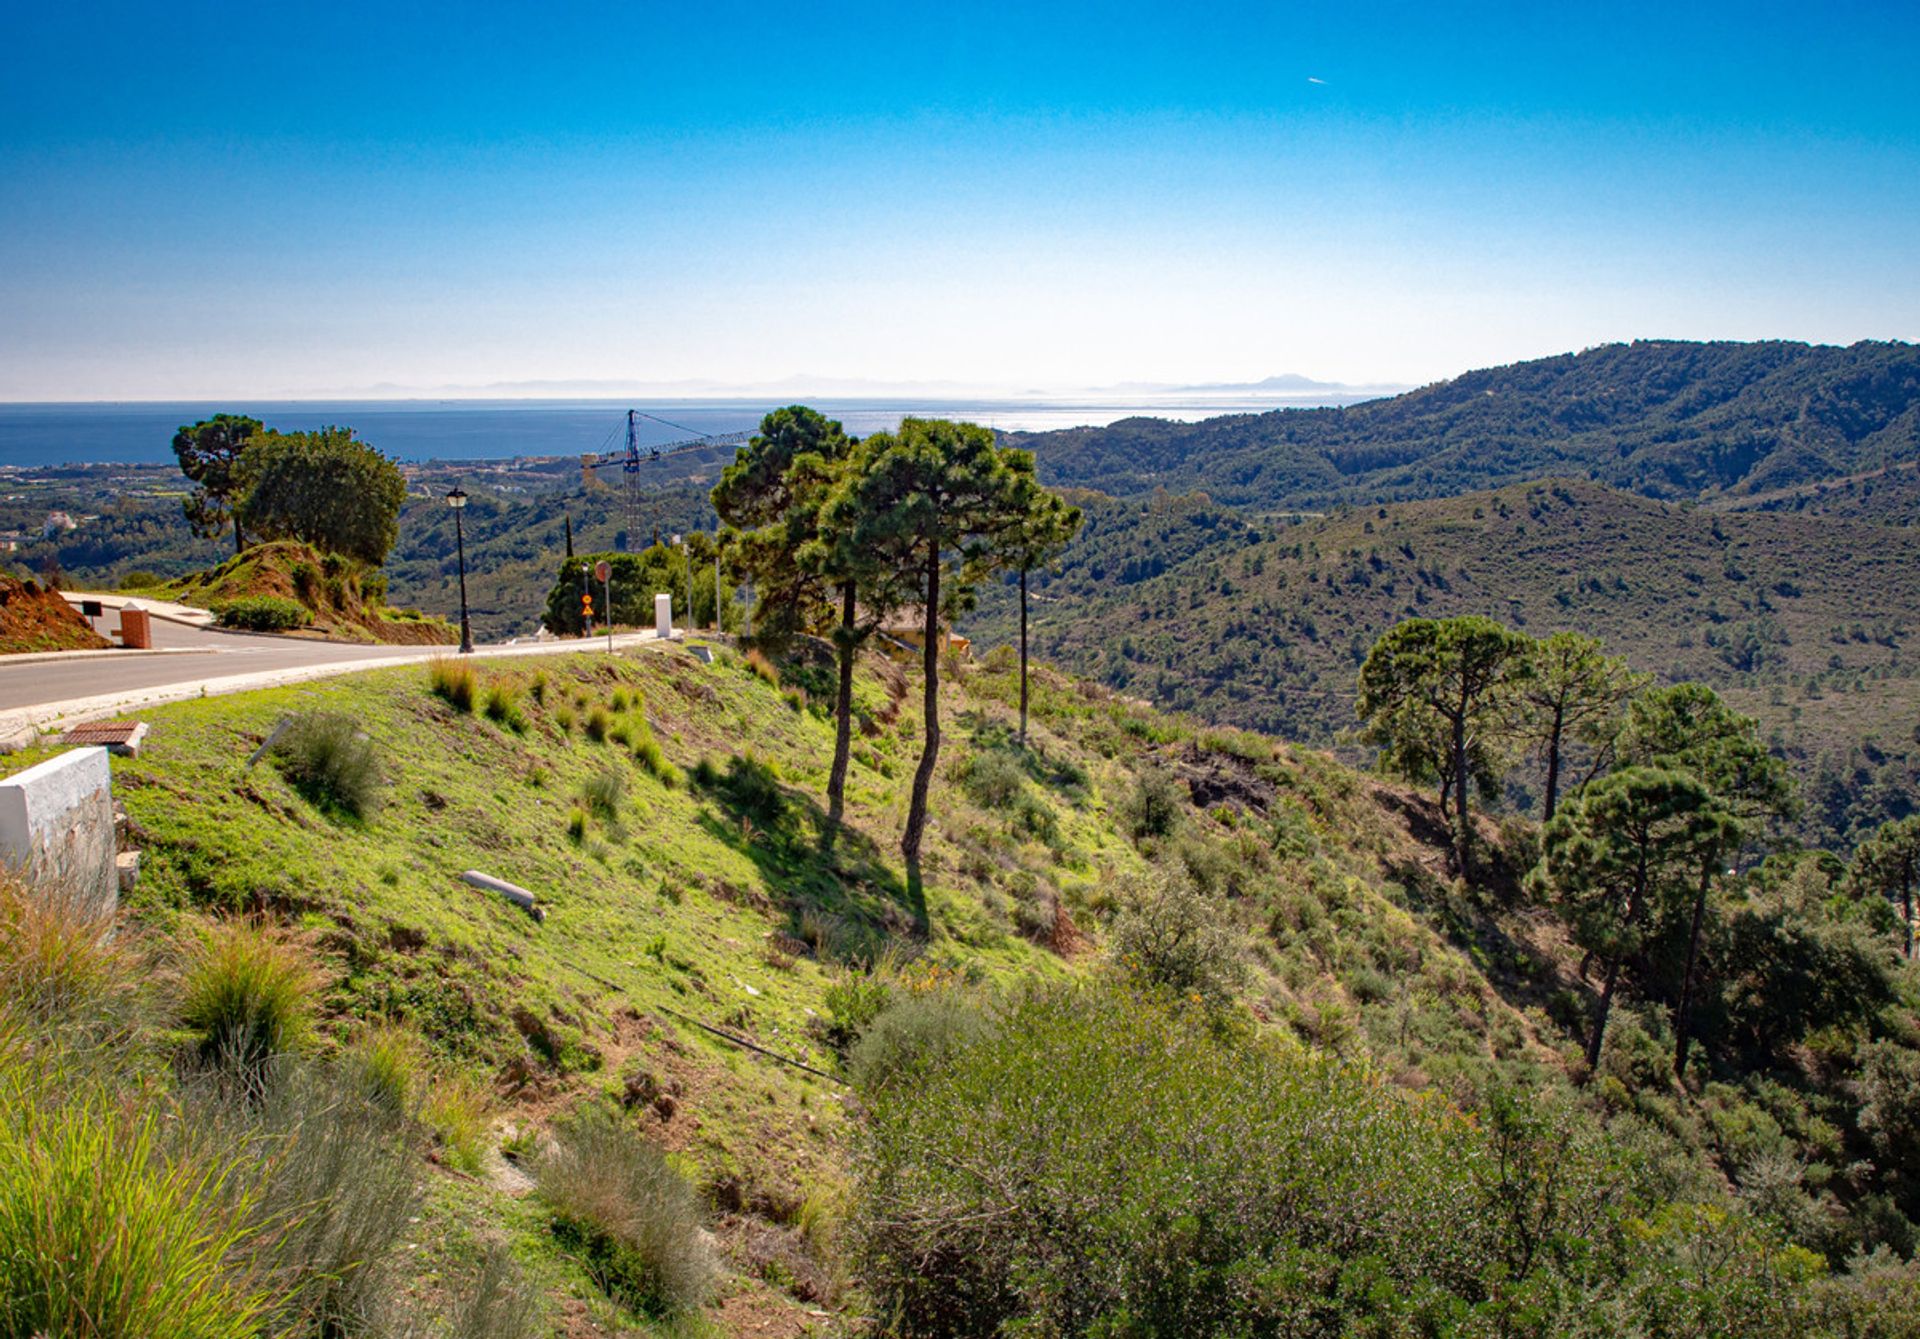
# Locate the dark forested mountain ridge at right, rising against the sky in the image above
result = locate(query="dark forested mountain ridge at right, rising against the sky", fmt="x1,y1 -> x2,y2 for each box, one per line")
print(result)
1014,340 -> 1920,511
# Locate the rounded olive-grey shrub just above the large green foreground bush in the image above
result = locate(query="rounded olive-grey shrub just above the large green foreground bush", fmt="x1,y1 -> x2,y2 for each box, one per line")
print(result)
1112,868 -> 1246,1009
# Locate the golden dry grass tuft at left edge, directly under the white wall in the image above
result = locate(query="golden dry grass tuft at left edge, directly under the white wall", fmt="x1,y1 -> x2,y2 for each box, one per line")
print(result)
0,868 -> 138,1022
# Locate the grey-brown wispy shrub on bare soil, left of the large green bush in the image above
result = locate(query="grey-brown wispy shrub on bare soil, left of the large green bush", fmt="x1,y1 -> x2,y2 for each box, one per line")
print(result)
534,1107 -> 712,1316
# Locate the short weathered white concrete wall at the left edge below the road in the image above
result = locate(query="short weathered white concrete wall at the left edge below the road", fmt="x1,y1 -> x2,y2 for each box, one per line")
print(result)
0,749 -> 119,909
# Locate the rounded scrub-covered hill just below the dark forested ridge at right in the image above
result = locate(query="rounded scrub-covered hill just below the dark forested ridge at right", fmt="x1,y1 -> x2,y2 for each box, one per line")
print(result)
983,480 -> 1920,787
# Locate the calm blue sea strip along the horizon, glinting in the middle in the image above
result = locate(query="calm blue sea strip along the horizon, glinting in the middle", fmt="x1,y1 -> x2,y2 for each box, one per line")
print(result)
0,398 -> 1344,465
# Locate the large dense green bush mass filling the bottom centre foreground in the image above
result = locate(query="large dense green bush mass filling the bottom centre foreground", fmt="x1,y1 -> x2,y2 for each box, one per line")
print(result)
852,982 -> 1843,1339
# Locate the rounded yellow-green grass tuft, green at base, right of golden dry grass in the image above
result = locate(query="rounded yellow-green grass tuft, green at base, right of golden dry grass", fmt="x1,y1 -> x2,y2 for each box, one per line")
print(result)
180,920 -> 315,1076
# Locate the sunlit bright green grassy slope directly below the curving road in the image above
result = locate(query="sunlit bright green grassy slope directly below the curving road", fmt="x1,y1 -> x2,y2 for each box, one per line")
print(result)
0,649 -> 1572,1333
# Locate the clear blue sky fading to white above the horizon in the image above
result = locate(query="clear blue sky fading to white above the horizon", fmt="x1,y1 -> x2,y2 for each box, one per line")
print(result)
0,0 -> 1920,400
